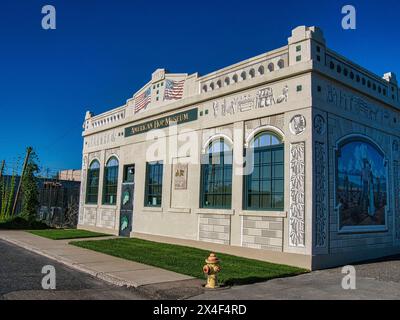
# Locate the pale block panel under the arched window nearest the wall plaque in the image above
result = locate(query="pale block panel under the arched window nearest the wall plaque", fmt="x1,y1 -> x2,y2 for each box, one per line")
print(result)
199,214 -> 231,244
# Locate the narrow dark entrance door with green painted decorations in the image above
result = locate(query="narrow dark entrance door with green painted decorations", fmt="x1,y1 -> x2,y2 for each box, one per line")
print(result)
119,165 -> 135,237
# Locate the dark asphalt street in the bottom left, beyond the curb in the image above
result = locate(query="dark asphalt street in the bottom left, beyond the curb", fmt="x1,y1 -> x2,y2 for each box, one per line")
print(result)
0,240 -> 147,300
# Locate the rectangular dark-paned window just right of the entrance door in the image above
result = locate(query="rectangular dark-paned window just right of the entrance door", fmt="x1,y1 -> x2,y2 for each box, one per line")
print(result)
144,161 -> 163,207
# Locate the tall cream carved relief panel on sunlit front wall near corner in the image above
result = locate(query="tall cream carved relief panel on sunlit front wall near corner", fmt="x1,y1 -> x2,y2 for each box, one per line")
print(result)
289,142 -> 305,247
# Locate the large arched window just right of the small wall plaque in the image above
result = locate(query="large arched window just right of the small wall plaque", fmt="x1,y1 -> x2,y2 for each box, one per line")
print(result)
200,138 -> 232,209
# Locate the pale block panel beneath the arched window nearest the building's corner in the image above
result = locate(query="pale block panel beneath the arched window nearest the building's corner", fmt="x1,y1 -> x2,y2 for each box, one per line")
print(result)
242,216 -> 283,252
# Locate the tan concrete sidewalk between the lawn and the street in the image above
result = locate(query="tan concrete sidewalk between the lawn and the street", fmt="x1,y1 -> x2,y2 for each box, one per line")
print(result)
0,230 -> 193,288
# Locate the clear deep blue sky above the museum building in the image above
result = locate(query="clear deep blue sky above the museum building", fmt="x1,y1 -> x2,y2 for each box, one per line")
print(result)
0,0 -> 400,175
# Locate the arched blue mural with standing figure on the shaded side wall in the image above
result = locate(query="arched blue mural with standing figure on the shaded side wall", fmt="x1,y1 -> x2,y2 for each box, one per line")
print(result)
336,139 -> 387,230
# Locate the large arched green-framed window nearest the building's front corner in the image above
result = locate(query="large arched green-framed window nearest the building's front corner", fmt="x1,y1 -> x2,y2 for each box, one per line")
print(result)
244,131 -> 284,211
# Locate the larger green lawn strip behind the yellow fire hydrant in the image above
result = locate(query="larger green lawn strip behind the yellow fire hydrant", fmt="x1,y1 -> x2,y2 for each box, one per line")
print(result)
71,238 -> 308,285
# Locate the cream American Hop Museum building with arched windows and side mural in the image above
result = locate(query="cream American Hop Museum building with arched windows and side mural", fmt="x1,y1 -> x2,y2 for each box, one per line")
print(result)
78,26 -> 400,269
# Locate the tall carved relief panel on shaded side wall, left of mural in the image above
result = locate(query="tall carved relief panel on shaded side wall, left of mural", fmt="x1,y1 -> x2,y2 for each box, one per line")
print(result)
314,142 -> 328,247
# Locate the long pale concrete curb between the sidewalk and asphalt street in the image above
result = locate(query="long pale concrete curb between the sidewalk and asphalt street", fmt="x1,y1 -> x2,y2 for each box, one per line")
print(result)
0,237 -> 140,289
